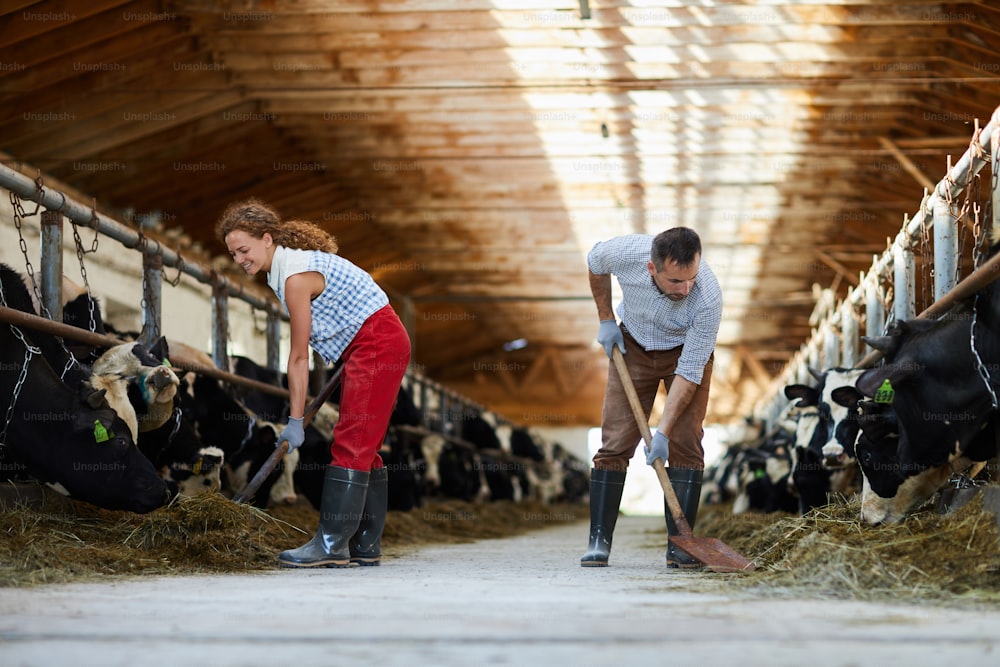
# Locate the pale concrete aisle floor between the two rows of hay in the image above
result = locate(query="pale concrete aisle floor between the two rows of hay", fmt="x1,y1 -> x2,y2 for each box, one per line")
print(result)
0,517 -> 1000,667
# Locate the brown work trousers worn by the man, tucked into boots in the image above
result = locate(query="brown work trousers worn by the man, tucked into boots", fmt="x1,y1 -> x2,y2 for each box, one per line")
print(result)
594,328 -> 715,471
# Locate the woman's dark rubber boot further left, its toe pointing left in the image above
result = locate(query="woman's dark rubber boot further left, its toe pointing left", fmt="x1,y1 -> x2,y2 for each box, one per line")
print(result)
278,466 -> 368,567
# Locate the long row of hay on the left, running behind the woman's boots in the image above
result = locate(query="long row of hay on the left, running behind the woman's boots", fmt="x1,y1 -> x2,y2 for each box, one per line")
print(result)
0,486 -> 587,587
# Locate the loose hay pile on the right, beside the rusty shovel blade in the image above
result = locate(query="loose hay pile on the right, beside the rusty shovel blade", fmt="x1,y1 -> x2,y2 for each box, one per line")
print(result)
697,495 -> 1000,603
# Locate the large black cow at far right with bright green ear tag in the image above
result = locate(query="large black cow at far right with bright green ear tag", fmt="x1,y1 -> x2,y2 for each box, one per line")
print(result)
839,310 -> 1000,524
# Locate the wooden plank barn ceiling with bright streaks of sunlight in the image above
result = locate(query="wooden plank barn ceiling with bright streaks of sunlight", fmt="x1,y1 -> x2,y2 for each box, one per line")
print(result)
0,0 -> 1000,425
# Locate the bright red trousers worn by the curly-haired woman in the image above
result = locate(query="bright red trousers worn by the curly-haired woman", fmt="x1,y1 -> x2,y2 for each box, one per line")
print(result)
330,305 -> 410,472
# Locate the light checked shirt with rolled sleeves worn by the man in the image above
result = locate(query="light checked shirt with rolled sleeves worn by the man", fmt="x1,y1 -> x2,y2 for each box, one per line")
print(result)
587,234 -> 722,384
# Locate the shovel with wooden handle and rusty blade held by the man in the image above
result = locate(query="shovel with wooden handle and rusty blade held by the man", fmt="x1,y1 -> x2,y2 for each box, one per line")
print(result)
612,346 -> 754,572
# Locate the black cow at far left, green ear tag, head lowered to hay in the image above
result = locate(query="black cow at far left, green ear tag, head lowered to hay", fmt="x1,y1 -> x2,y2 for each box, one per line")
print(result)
0,265 -> 169,513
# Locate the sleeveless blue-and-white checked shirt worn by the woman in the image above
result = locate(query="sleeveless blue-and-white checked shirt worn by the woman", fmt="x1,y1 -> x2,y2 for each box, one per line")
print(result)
267,246 -> 389,363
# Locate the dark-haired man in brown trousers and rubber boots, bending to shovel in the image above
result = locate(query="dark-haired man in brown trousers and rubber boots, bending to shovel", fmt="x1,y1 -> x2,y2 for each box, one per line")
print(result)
580,227 -> 722,567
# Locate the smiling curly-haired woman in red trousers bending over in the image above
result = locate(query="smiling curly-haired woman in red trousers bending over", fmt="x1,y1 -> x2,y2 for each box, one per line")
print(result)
216,199 -> 410,567
